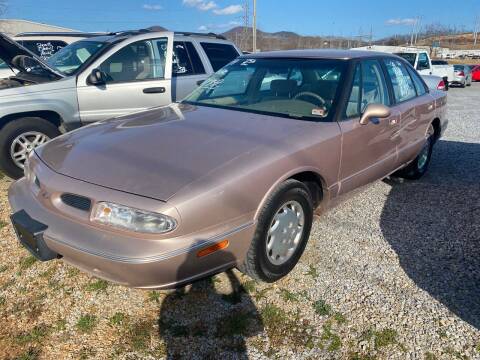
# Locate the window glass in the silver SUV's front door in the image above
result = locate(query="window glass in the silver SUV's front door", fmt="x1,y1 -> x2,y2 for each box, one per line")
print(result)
99,38 -> 167,83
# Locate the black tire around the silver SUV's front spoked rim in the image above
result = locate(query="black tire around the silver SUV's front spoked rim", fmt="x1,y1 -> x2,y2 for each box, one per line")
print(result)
0,117 -> 60,179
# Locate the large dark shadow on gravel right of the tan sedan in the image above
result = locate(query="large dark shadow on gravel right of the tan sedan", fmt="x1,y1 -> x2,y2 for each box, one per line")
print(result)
380,141 -> 480,329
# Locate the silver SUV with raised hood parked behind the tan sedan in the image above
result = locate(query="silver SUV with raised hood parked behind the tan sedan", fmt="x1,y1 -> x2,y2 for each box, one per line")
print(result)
0,30 -> 241,178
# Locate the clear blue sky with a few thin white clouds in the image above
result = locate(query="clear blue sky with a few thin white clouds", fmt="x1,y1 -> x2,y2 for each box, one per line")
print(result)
3,0 -> 480,39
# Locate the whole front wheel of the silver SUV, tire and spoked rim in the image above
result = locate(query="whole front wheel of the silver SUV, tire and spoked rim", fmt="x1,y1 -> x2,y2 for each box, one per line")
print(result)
0,117 -> 60,179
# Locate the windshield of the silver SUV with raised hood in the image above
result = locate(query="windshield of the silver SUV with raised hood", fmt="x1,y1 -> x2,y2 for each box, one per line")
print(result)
47,40 -> 107,75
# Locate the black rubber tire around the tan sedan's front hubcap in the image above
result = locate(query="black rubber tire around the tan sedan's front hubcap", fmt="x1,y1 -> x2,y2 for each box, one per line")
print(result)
238,179 -> 313,282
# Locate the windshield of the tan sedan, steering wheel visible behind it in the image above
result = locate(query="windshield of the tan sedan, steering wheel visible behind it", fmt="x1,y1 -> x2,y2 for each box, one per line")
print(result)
184,57 -> 346,120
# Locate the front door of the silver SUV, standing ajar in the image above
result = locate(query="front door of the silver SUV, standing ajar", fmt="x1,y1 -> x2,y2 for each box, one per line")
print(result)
77,33 -> 173,123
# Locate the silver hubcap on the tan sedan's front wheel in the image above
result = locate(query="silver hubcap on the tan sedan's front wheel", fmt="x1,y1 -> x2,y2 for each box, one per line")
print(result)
266,201 -> 305,265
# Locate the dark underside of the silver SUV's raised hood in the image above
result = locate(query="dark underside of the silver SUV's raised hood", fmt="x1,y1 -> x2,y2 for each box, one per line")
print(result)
0,33 -> 64,80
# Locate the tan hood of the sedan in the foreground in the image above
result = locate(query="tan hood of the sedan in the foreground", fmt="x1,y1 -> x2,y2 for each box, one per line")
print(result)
36,104 -> 302,201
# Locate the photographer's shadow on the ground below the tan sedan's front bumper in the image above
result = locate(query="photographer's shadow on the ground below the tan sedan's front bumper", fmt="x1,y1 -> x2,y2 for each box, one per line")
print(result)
158,253 -> 263,359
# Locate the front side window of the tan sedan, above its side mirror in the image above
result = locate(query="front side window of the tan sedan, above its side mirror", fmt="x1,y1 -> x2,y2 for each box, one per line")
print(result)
345,60 -> 390,118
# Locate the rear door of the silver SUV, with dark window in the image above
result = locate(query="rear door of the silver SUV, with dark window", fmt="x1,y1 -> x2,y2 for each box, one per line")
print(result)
172,41 -> 208,101
